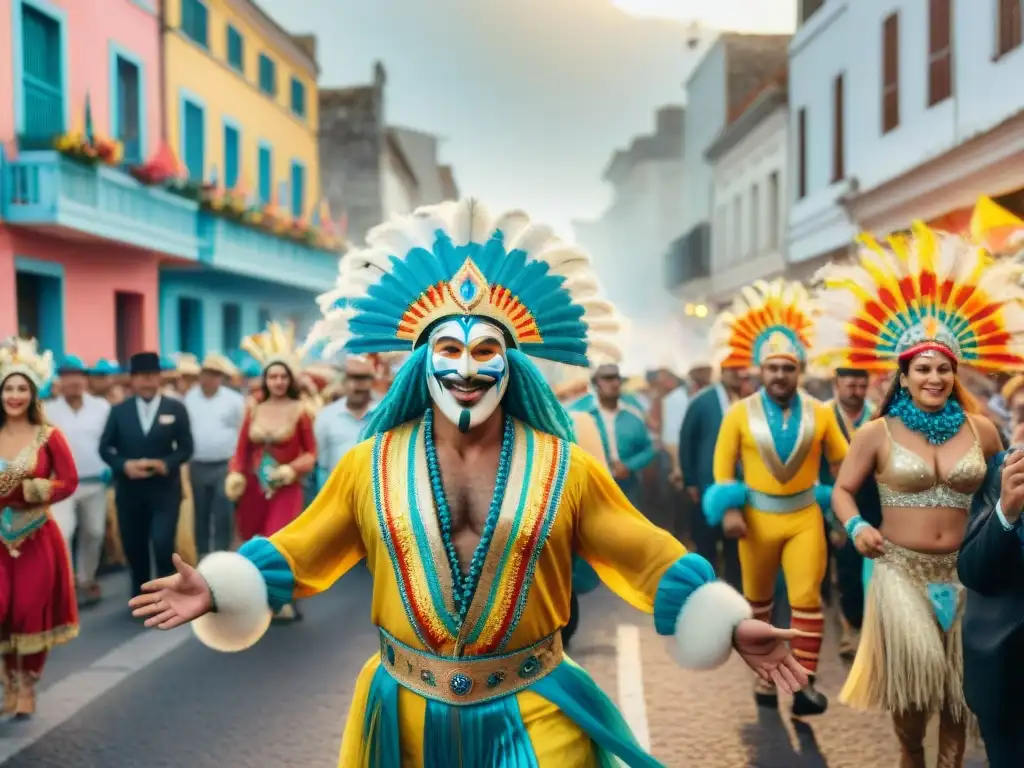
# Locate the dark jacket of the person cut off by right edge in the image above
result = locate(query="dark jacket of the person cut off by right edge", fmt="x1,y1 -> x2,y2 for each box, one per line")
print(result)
957,483 -> 1024,728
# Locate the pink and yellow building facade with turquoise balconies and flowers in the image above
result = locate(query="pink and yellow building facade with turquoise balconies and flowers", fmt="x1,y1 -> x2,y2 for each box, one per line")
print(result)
0,0 -> 339,359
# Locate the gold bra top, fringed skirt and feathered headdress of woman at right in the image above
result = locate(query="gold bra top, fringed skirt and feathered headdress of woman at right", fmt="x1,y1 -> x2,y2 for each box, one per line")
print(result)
818,223 -> 1024,768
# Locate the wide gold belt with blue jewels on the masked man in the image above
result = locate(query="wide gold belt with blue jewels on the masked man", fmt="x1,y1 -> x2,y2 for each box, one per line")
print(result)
380,630 -> 563,706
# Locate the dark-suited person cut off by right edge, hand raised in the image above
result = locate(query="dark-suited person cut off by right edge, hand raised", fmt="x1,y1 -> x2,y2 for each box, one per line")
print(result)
957,451 -> 1024,768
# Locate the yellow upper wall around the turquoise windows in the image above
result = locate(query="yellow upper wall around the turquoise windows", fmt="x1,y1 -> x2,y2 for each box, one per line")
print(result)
164,0 -> 321,213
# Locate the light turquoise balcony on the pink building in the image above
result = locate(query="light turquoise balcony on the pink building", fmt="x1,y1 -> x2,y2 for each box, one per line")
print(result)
0,152 -> 199,259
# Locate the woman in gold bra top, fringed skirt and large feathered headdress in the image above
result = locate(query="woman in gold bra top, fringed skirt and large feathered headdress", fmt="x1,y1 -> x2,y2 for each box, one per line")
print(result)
818,224 -> 1011,766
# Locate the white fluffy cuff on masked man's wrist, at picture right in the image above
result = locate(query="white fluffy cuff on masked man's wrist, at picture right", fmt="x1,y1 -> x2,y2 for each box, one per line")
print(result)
673,582 -> 754,670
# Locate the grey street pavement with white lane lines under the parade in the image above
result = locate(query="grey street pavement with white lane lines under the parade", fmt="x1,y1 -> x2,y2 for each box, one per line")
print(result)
0,567 -> 985,768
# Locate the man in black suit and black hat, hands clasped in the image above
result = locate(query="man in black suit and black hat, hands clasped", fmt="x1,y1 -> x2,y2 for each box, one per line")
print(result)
99,352 -> 193,595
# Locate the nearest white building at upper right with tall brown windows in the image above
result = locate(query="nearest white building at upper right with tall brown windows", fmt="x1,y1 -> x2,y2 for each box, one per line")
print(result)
788,0 -> 1024,267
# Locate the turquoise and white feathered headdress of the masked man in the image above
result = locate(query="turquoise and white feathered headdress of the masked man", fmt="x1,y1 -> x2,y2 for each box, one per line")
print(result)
307,200 -> 622,367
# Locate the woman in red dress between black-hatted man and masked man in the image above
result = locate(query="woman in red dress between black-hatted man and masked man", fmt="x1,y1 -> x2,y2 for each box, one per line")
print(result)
225,323 -> 316,621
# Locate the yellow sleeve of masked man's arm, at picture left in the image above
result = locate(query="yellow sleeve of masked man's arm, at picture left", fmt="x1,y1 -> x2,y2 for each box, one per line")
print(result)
269,441 -> 373,597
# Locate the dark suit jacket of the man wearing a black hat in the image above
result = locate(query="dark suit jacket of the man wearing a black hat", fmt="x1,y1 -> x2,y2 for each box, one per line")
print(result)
99,397 -> 193,492
